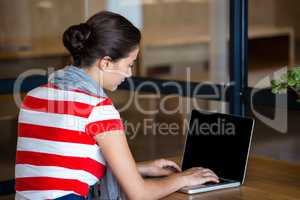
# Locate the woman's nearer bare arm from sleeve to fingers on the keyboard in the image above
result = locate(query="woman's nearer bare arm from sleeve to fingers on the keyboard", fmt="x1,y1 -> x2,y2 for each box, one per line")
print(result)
95,131 -> 218,200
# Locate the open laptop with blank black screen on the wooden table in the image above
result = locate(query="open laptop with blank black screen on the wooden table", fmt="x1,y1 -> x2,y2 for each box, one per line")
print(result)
180,110 -> 254,194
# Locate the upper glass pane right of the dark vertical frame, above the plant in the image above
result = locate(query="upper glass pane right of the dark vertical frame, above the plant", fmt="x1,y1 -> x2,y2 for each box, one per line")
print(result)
248,0 -> 298,87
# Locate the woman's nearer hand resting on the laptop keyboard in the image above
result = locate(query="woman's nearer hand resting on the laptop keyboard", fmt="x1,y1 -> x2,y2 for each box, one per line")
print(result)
180,167 -> 219,186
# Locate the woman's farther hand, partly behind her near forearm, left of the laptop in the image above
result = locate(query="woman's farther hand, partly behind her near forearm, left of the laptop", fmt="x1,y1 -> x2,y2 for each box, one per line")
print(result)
137,159 -> 181,177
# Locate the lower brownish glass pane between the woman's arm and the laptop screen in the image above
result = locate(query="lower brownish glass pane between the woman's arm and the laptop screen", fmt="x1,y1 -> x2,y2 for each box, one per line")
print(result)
109,90 -> 210,161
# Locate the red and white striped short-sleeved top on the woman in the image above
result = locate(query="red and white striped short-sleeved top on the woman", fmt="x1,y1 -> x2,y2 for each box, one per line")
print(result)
15,84 -> 124,199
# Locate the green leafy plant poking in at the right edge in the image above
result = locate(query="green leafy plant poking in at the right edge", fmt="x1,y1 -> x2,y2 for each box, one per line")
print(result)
271,66 -> 300,103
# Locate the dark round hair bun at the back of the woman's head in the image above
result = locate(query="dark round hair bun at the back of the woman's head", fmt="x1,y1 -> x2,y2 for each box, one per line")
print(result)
63,23 -> 91,53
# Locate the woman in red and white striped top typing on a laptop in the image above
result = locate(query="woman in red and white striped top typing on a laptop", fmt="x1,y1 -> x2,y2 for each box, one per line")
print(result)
16,11 -> 218,200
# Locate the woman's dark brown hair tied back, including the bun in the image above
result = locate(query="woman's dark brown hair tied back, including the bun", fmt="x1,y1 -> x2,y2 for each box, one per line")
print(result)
63,11 -> 141,67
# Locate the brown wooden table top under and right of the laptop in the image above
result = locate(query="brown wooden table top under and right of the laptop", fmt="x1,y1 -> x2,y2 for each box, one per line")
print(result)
164,157 -> 300,200
